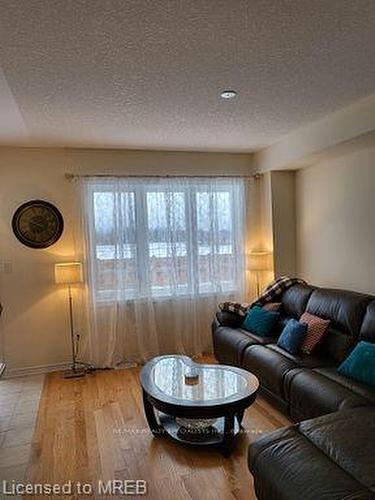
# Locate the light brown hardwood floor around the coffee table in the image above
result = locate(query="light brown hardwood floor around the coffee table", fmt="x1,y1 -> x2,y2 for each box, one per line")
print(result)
27,360 -> 289,500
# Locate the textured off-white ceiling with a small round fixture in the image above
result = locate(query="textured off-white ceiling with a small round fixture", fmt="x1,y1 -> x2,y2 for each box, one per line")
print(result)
0,0 -> 375,151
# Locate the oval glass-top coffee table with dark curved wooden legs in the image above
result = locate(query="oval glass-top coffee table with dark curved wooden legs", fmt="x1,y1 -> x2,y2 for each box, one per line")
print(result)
141,355 -> 259,456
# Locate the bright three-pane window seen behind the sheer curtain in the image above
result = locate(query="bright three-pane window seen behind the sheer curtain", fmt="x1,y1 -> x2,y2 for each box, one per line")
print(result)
88,178 -> 245,300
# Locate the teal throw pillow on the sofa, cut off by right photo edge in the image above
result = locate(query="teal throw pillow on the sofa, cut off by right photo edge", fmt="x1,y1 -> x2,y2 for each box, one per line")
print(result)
337,340 -> 375,387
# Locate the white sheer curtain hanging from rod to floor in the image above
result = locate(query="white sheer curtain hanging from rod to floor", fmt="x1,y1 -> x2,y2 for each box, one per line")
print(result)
80,177 -> 247,367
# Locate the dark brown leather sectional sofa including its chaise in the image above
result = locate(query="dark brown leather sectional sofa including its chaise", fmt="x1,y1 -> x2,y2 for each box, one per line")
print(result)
212,285 -> 375,500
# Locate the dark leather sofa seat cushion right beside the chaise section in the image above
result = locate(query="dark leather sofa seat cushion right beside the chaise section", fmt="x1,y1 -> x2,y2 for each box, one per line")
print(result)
284,368 -> 370,421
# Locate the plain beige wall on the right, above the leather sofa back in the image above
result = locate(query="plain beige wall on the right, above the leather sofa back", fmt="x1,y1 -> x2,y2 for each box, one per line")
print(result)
296,148 -> 375,294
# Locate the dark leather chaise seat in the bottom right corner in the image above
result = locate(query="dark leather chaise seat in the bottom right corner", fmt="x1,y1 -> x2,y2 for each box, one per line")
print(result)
248,409 -> 375,500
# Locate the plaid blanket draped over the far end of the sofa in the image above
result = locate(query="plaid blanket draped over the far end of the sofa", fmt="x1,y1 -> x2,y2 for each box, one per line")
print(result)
219,276 -> 306,317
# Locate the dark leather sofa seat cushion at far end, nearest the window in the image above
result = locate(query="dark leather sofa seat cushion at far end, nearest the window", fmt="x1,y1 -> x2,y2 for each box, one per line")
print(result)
212,325 -> 274,366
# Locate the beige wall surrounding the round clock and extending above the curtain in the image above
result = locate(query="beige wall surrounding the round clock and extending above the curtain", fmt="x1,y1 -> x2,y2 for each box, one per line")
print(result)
0,148 -> 252,370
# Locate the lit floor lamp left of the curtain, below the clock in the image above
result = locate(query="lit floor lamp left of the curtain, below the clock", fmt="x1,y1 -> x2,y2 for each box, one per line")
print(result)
55,262 -> 87,378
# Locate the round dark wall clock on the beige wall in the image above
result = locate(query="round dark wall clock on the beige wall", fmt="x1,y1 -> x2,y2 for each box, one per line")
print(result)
12,200 -> 64,248
